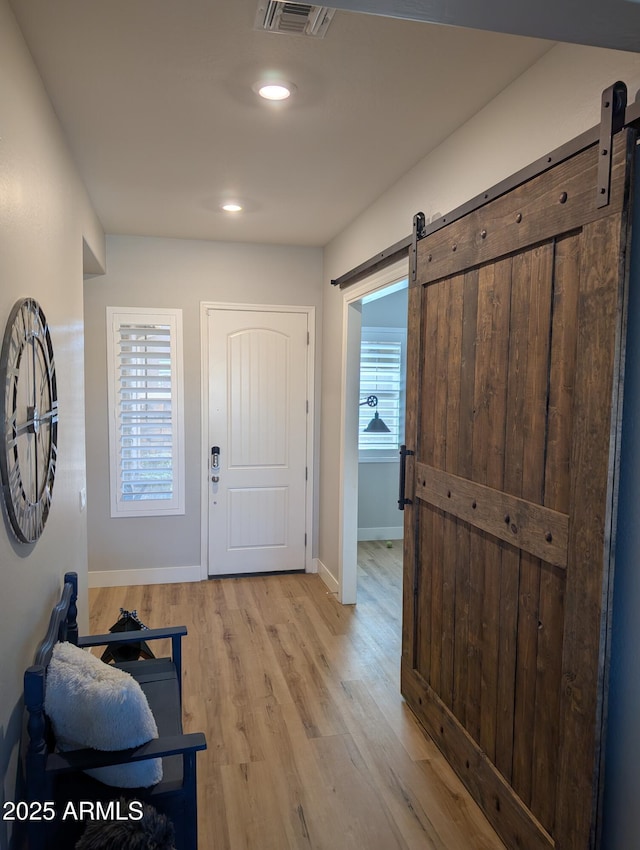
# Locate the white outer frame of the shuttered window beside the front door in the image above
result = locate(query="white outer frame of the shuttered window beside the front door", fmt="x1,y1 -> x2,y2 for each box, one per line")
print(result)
106,307 -> 185,518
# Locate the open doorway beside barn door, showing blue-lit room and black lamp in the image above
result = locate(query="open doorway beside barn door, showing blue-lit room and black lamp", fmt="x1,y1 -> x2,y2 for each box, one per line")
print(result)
339,260 -> 408,604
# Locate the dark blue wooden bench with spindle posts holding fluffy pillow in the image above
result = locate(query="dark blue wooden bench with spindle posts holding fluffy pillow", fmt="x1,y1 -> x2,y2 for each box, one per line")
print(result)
24,572 -> 207,850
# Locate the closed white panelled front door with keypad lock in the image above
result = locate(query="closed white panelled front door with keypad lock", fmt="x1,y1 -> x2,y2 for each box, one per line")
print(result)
208,308 -> 308,575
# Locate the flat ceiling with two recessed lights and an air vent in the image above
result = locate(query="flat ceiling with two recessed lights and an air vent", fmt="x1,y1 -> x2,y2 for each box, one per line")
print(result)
7,0 -> 564,246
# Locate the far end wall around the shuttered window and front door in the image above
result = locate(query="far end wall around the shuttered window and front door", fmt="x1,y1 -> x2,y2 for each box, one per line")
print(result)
85,236 -> 322,585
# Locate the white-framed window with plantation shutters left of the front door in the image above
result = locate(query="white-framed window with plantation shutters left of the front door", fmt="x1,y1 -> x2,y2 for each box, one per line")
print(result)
107,307 -> 184,517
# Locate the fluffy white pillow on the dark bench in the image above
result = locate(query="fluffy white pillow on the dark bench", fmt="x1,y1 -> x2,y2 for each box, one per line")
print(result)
44,643 -> 162,788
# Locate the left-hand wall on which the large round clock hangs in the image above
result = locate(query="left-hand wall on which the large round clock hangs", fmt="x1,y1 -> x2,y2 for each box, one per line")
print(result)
0,0 -> 104,849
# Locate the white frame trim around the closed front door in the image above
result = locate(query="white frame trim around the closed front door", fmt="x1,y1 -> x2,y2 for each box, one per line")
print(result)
200,301 -> 317,580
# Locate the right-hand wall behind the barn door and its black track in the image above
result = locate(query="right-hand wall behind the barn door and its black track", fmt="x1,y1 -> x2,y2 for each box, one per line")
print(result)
319,36 -> 640,850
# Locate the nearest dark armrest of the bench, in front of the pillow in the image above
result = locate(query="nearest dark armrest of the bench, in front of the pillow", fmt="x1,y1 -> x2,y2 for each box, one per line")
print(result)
45,732 -> 207,773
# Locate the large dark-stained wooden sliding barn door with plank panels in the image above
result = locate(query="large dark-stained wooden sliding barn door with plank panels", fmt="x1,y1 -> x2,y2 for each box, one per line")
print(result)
402,130 -> 634,850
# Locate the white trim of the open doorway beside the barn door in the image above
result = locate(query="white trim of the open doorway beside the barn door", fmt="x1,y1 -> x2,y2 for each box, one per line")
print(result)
338,256 -> 409,605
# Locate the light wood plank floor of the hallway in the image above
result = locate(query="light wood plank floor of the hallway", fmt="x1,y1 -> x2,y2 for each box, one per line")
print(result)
90,542 -> 504,850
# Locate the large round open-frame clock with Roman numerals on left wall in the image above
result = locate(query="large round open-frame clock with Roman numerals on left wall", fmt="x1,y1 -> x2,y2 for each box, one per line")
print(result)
0,298 -> 58,543
